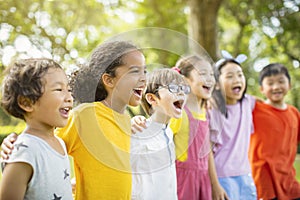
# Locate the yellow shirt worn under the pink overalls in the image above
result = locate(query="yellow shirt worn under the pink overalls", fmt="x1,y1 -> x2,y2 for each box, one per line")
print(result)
170,109 -> 206,162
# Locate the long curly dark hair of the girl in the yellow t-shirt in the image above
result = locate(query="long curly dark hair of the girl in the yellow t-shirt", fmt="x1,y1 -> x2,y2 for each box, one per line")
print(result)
71,41 -> 140,103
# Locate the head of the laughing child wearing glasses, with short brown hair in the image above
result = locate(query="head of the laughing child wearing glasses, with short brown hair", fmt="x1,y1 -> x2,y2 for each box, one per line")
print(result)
142,68 -> 191,123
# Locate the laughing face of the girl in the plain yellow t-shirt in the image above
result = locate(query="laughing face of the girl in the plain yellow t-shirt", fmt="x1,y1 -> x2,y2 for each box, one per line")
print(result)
110,50 -> 146,112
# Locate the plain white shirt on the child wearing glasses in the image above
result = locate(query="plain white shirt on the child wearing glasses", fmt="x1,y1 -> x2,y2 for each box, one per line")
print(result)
131,122 -> 177,200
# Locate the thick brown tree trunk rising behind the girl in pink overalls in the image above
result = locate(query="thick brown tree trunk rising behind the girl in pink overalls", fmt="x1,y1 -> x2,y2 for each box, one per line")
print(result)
188,0 -> 223,60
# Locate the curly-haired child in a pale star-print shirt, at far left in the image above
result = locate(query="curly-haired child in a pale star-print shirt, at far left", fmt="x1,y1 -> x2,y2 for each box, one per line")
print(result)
0,58 -> 73,200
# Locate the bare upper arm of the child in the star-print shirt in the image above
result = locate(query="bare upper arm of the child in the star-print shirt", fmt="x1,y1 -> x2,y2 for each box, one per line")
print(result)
0,162 -> 33,200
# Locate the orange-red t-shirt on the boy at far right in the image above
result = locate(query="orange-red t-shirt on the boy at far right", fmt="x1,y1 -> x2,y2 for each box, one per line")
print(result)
249,102 -> 300,199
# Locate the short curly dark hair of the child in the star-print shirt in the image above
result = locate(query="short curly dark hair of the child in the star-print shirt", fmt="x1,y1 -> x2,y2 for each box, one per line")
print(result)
1,58 -> 62,120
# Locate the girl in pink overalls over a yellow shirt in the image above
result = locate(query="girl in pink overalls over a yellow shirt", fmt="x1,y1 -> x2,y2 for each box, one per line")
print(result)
132,55 -> 228,200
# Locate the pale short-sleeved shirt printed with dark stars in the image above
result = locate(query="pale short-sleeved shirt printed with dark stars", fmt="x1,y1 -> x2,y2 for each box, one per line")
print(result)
3,133 -> 73,200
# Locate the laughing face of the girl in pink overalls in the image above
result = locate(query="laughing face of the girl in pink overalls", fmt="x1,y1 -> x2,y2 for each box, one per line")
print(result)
187,60 -> 216,99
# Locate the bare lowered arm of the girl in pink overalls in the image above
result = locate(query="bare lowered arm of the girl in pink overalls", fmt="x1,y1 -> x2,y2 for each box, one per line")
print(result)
208,151 -> 229,200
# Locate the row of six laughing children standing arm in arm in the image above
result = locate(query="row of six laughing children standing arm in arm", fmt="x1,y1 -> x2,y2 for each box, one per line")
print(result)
0,41 -> 300,200
